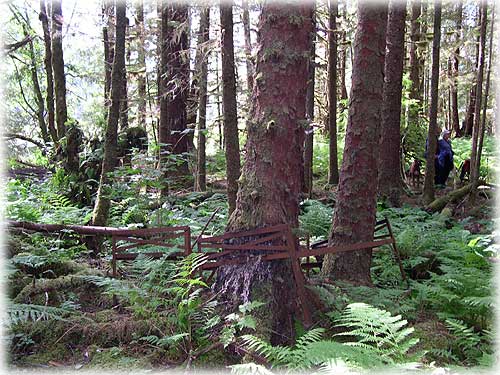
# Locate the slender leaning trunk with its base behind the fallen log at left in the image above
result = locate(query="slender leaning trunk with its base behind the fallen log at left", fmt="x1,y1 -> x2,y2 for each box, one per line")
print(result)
92,1 -> 127,226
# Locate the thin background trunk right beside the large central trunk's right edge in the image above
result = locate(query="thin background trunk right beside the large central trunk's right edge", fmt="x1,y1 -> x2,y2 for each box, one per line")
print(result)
303,3 -> 316,197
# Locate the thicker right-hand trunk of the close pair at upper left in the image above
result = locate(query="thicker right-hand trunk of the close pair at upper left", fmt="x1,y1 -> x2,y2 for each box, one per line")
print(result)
51,0 -> 68,138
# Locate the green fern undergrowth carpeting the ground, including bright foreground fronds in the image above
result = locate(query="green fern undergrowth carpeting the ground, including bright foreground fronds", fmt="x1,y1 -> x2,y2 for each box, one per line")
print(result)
6,173 -> 498,373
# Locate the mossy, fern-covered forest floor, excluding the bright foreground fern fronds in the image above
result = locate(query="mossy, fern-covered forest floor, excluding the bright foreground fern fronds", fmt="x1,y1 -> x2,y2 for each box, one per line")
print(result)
8,173 -> 498,372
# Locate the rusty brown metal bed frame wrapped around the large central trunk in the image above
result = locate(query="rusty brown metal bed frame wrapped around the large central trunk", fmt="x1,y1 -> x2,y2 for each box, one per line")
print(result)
112,219 -> 407,325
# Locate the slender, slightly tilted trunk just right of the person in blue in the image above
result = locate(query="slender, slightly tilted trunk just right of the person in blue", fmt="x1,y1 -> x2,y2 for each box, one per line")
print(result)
470,0 -> 488,188
